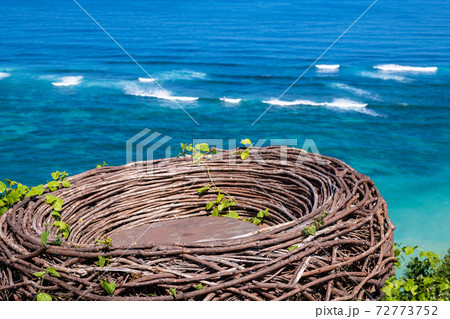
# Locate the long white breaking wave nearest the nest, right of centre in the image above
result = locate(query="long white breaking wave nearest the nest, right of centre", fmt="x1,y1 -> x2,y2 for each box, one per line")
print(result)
263,99 -> 380,116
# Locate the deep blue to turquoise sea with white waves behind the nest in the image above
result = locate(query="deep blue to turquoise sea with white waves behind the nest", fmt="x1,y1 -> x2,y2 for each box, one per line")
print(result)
0,0 -> 450,253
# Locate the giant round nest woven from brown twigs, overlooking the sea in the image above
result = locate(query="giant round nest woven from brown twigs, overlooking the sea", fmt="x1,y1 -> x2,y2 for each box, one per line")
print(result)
0,147 -> 395,300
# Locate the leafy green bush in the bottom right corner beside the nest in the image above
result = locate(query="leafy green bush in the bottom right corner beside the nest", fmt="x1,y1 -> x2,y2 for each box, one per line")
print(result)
382,245 -> 450,301
